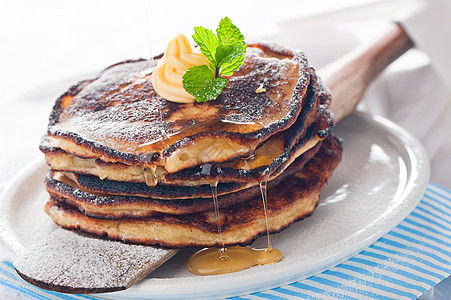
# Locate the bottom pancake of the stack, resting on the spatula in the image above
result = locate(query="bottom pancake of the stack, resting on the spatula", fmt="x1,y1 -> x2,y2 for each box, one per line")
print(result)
45,136 -> 342,247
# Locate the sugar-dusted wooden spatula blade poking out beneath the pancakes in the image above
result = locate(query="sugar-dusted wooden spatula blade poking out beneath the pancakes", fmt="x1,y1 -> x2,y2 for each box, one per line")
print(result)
14,229 -> 177,292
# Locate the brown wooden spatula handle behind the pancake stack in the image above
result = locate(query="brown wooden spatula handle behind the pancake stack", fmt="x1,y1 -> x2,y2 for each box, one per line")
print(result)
319,24 -> 413,123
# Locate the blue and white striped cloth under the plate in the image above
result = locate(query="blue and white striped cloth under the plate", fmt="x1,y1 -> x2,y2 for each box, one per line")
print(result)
0,183 -> 451,299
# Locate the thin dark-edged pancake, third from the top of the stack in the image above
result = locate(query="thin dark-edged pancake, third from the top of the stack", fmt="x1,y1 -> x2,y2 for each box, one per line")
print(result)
59,128 -> 321,199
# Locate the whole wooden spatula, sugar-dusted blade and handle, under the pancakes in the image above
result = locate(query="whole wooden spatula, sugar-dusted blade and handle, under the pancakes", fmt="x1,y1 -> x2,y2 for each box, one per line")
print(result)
14,25 -> 413,293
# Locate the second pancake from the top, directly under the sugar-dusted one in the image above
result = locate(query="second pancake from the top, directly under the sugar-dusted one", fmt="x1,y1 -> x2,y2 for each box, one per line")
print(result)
40,69 -> 333,190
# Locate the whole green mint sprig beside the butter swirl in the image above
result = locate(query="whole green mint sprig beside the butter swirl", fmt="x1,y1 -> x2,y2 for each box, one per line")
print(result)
182,17 -> 246,102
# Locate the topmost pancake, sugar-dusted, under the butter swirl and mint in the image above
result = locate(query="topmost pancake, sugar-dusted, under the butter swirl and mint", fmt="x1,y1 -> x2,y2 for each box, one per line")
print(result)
48,44 -> 310,173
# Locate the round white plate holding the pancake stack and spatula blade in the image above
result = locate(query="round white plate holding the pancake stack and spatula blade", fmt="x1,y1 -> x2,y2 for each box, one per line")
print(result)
0,112 -> 429,299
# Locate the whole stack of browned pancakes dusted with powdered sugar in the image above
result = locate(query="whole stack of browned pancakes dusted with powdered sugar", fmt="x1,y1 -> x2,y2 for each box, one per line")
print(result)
40,44 -> 341,247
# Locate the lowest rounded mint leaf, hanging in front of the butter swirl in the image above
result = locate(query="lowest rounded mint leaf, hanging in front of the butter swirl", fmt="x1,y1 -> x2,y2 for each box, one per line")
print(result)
182,65 -> 227,102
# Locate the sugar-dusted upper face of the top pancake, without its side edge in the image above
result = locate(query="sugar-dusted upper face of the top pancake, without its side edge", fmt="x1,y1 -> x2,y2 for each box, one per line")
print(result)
48,47 -> 308,156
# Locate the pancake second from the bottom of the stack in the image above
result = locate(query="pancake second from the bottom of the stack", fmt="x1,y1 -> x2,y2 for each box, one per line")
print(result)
45,138 -> 321,219
